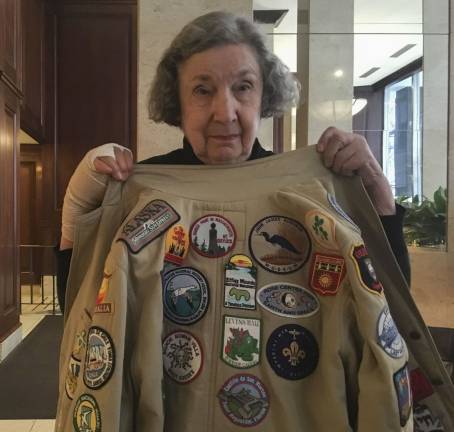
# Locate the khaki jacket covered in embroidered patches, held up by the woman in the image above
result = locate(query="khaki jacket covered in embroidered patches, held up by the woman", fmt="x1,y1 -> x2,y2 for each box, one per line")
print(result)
55,148 -> 454,432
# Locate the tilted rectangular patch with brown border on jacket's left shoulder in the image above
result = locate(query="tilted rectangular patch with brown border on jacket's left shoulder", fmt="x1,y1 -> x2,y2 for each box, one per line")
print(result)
118,200 -> 180,253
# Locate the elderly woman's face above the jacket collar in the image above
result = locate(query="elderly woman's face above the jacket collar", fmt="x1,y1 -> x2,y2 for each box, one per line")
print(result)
178,44 -> 263,164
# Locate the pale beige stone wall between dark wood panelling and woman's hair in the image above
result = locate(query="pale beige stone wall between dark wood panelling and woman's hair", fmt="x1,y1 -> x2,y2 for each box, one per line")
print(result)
137,0 -> 252,160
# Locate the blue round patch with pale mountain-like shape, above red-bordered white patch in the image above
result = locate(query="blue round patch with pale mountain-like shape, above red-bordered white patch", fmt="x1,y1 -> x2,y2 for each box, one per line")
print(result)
163,267 -> 209,324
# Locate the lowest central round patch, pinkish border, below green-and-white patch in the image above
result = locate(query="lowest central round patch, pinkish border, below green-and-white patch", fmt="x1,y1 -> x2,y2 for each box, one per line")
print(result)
218,374 -> 270,426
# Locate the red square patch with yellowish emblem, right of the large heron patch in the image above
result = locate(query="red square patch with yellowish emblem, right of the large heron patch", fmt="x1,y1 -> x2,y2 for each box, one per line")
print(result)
309,253 -> 346,295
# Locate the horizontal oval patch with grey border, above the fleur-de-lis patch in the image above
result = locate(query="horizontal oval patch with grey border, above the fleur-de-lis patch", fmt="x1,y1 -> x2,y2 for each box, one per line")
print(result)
257,282 -> 320,318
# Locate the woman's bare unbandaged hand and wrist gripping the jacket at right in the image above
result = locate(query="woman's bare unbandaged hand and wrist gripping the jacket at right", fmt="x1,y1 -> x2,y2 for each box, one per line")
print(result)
317,127 -> 396,216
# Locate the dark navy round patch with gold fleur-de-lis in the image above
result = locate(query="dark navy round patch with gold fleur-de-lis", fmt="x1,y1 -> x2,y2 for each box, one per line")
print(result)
266,324 -> 318,380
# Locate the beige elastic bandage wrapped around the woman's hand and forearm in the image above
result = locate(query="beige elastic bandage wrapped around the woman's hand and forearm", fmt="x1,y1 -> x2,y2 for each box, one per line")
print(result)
61,143 -> 130,242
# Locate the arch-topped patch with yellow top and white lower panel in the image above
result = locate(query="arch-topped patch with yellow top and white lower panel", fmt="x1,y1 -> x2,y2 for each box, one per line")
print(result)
224,254 -> 257,309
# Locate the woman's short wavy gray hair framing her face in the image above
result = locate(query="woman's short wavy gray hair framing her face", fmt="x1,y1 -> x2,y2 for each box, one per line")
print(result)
148,12 -> 300,126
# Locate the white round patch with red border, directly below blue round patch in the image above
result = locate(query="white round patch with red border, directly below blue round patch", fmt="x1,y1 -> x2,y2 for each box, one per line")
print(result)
162,331 -> 203,384
